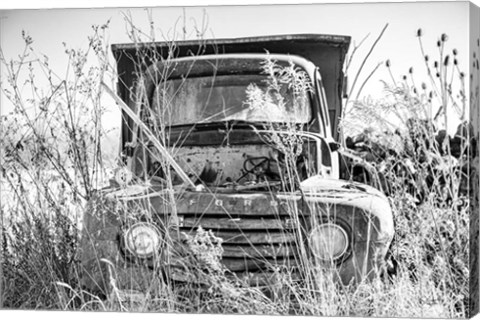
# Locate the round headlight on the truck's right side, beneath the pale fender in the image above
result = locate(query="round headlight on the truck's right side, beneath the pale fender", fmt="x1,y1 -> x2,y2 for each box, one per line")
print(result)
309,223 -> 348,261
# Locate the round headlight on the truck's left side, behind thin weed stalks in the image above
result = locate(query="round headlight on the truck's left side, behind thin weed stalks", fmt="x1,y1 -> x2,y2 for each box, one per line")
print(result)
125,223 -> 161,258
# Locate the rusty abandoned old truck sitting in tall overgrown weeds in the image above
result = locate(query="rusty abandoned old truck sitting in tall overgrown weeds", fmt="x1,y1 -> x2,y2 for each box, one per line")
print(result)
79,34 -> 394,294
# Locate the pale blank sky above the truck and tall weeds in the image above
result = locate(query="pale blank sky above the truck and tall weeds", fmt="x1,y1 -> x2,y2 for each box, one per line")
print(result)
0,0 -> 480,138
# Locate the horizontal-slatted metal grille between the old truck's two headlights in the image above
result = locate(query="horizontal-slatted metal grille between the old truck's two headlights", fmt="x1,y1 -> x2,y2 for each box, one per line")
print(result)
169,193 -> 304,273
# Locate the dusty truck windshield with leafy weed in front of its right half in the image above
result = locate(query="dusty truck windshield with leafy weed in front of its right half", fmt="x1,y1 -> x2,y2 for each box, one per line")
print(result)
152,74 -> 311,126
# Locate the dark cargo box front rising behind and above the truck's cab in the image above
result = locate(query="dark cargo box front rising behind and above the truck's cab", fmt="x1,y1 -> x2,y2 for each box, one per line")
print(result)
112,34 -> 351,141
